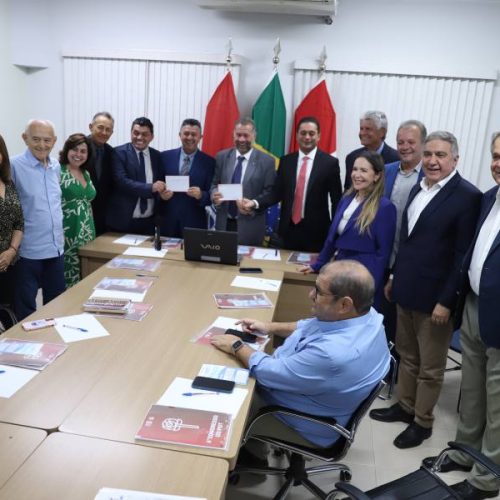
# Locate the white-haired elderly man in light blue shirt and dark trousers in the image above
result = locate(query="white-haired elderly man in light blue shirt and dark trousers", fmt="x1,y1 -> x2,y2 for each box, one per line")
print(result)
10,120 -> 65,320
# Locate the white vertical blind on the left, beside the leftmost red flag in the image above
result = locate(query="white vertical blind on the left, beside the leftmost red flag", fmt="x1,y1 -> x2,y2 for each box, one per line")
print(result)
60,56 -> 239,150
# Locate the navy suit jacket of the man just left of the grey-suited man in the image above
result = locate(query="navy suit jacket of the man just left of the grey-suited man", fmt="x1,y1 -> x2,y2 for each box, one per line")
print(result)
159,148 -> 215,238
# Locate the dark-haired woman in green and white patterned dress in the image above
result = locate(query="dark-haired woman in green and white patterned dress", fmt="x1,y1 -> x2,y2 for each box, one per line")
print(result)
59,134 -> 96,288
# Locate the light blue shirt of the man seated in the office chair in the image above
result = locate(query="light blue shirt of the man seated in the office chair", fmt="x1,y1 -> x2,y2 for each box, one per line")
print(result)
249,308 -> 389,447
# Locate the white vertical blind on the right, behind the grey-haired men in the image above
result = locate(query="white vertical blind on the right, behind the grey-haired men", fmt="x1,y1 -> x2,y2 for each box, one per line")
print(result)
293,68 -> 494,184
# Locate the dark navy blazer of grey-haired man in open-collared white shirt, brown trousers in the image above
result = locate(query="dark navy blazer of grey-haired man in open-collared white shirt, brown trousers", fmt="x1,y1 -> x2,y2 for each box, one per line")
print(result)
392,172 -> 481,314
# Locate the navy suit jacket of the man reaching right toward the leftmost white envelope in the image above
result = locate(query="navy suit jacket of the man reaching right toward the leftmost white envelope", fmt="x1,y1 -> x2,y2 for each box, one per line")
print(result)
106,142 -> 160,232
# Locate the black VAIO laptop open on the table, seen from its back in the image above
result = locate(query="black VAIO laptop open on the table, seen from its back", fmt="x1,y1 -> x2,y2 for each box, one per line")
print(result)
184,227 -> 238,266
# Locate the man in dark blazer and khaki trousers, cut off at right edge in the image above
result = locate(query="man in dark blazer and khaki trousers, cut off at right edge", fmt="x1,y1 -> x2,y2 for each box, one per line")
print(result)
424,132 -> 500,499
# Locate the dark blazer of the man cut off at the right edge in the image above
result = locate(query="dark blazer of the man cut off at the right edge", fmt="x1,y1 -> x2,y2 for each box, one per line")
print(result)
457,186 -> 500,349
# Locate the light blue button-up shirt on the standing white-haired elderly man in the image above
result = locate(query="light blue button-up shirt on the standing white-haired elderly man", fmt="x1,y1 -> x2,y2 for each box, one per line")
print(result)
10,149 -> 64,260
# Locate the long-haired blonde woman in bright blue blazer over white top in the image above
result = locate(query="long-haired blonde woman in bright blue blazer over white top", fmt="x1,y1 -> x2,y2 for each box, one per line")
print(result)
302,151 -> 396,307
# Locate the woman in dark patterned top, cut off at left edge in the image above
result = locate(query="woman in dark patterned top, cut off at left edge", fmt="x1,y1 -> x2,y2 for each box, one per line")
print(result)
0,135 -> 24,306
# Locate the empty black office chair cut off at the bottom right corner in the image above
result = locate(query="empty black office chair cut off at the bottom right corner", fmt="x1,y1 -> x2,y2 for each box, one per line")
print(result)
327,441 -> 500,500
